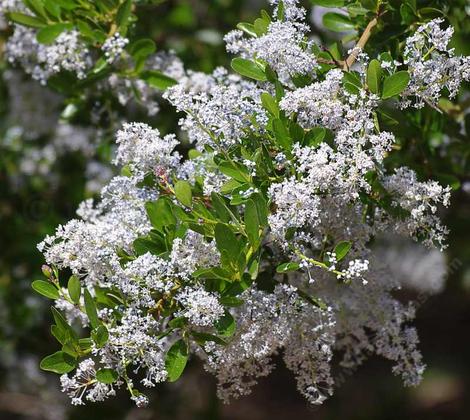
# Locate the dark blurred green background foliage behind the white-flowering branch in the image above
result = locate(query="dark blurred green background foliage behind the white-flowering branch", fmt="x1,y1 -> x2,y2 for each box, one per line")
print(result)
0,0 -> 470,420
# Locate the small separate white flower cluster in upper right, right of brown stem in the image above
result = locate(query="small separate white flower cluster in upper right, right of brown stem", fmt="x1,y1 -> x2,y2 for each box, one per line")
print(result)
402,19 -> 470,108
